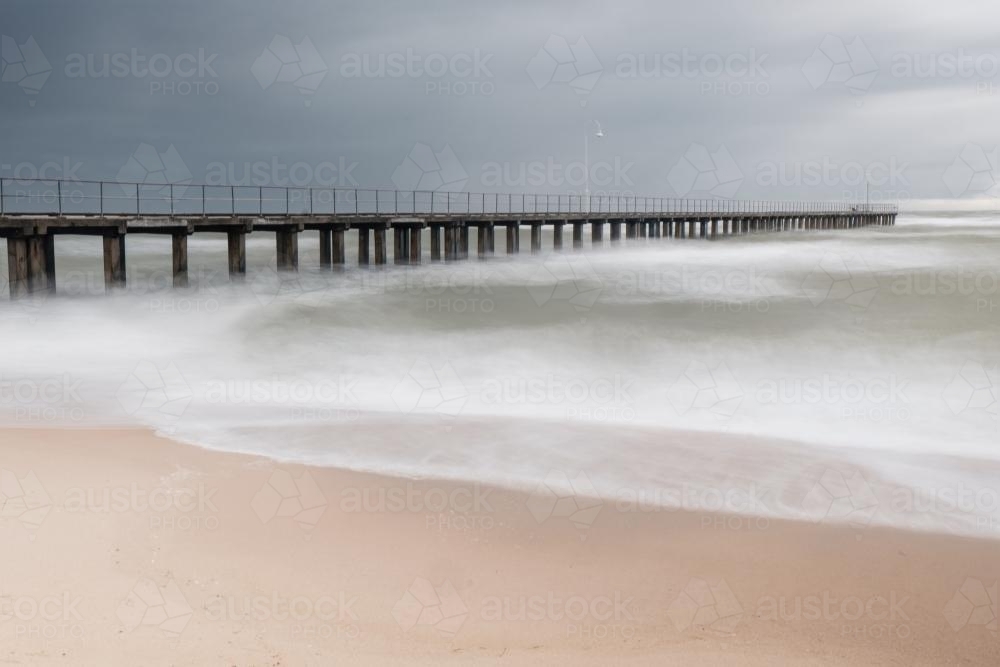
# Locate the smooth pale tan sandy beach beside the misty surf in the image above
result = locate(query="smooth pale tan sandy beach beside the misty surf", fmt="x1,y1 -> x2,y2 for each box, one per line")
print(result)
0,429 -> 1000,666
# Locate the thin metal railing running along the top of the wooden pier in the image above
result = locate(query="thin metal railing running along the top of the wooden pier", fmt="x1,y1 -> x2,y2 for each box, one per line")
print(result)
0,178 -> 898,216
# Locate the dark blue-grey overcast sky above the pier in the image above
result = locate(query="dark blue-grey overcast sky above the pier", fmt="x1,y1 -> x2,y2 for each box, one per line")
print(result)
0,0 -> 1000,206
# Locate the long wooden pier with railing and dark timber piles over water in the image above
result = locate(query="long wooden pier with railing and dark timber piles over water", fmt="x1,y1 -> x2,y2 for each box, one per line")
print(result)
0,179 -> 898,298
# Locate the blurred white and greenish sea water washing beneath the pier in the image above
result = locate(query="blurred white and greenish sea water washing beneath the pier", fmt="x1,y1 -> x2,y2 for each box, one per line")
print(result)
0,215 -> 1000,536
